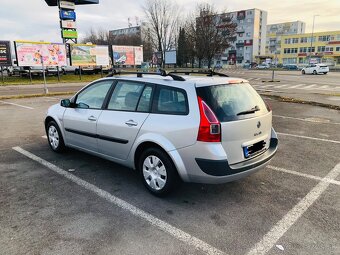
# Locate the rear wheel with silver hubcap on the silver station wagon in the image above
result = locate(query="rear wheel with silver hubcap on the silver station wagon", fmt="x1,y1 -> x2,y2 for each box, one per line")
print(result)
138,148 -> 179,197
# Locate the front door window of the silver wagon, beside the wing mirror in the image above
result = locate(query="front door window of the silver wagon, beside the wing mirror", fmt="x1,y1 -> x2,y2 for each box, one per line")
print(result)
76,80 -> 112,109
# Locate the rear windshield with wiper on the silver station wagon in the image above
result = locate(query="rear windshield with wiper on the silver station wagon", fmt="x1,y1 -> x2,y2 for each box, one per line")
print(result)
196,83 -> 268,122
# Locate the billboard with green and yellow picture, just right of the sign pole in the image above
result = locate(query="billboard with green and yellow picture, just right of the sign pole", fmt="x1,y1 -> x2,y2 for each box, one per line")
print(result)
70,44 -> 110,66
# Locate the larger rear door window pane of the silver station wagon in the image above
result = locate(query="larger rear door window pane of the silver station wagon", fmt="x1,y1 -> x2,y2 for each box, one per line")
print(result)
107,81 -> 144,111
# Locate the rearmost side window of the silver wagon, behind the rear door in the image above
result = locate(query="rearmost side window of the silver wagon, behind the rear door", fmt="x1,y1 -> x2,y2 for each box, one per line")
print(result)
156,87 -> 188,115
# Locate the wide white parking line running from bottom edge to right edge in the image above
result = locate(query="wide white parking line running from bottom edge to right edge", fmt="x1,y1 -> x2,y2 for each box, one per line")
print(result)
247,163 -> 340,255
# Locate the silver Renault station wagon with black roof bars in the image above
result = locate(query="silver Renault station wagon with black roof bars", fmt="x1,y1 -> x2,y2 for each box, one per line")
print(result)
45,71 -> 278,196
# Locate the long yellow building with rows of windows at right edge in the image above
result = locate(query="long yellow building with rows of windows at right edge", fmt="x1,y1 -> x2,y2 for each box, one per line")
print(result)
278,31 -> 340,66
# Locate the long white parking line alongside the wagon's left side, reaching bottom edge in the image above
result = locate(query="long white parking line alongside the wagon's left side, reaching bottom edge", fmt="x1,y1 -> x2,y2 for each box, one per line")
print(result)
13,147 -> 225,255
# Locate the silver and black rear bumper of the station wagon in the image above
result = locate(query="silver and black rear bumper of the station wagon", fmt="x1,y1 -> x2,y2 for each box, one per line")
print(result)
175,129 -> 278,184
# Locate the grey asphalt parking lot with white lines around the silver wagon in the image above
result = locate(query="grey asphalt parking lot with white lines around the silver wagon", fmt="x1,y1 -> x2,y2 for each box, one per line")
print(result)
0,94 -> 340,254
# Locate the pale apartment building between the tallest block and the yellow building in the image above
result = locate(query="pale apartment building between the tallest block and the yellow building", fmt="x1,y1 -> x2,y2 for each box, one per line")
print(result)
266,21 -> 306,63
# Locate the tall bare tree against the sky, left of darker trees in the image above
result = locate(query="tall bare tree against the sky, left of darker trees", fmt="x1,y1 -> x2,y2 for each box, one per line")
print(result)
144,0 -> 179,66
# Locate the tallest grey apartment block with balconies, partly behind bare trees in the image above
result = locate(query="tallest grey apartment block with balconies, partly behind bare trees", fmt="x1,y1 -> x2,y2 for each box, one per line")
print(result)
214,9 -> 267,65
